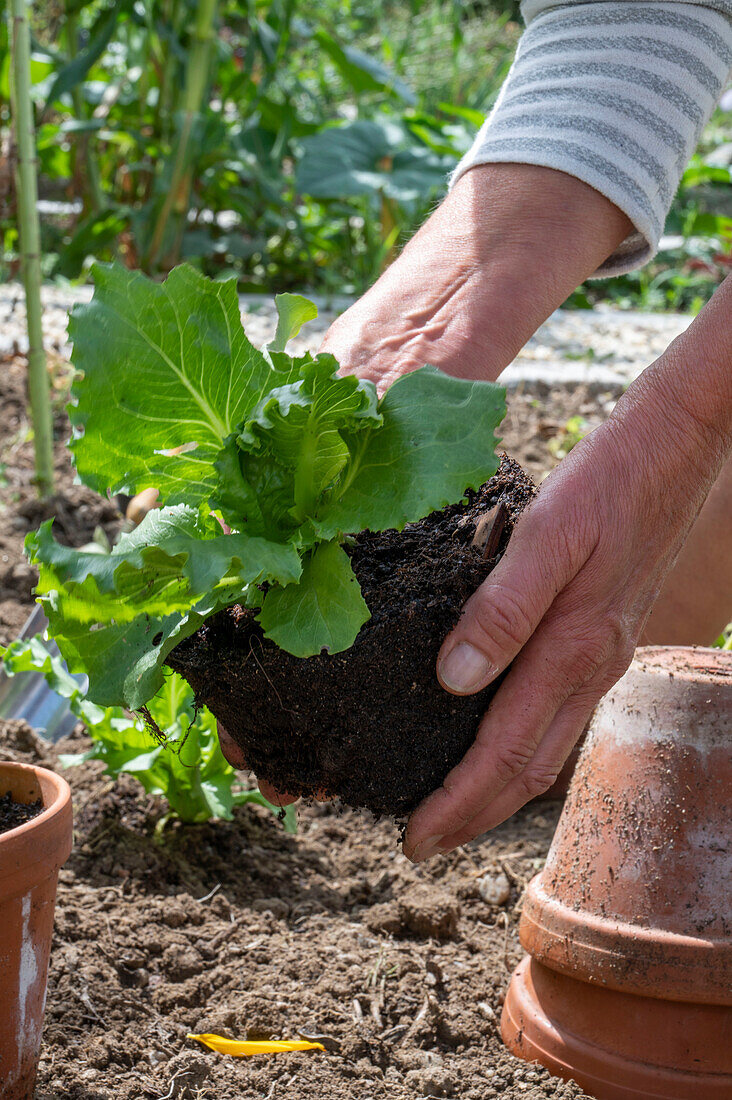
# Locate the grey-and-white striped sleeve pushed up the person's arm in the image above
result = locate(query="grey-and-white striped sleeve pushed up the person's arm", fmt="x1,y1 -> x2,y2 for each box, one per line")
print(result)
452,0 -> 732,276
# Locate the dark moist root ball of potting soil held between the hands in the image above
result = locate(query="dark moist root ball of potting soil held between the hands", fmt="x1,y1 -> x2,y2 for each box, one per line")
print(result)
167,455 -> 536,817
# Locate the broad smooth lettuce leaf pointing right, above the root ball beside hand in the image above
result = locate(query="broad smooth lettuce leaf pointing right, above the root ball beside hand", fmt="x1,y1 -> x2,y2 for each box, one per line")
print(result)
314,366 -> 505,539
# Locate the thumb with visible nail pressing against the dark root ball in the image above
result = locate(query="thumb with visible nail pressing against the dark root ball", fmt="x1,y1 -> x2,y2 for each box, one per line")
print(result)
437,498 -> 591,695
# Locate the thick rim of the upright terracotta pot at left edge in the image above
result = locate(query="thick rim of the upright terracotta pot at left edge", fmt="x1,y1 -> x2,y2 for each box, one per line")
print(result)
0,760 -> 72,897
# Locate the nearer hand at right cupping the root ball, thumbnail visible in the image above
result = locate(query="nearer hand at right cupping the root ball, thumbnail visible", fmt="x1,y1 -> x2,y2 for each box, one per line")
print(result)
404,325 -> 732,861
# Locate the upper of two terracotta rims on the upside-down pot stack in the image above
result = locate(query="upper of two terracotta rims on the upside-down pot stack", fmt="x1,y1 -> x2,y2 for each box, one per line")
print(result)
518,872 -> 732,1005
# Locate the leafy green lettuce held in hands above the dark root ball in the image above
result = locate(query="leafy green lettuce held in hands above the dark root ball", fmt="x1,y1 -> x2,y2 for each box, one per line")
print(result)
26,265 -> 505,710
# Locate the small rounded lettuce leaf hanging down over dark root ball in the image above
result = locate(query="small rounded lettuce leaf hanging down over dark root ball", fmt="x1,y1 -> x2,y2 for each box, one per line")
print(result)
259,542 -> 370,657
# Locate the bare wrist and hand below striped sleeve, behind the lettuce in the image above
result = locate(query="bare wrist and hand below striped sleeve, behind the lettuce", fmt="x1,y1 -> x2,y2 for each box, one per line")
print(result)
321,164 -> 631,393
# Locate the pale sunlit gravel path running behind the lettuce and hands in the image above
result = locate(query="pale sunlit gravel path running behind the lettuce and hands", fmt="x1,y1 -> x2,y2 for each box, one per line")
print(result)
0,283 -> 691,393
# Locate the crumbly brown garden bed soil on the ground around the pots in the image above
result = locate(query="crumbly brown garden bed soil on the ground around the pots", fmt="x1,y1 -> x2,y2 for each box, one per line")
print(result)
0,359 -> 608,1100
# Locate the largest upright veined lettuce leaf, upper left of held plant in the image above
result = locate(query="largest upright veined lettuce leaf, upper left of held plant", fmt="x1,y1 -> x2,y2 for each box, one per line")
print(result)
69,264 -> 276,506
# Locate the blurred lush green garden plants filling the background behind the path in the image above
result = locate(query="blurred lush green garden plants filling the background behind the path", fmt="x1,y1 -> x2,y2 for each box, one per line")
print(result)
0,0 -> 732,310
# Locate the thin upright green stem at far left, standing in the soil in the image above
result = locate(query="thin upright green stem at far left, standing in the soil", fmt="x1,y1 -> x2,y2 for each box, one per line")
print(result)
9,0 -> 53,496
